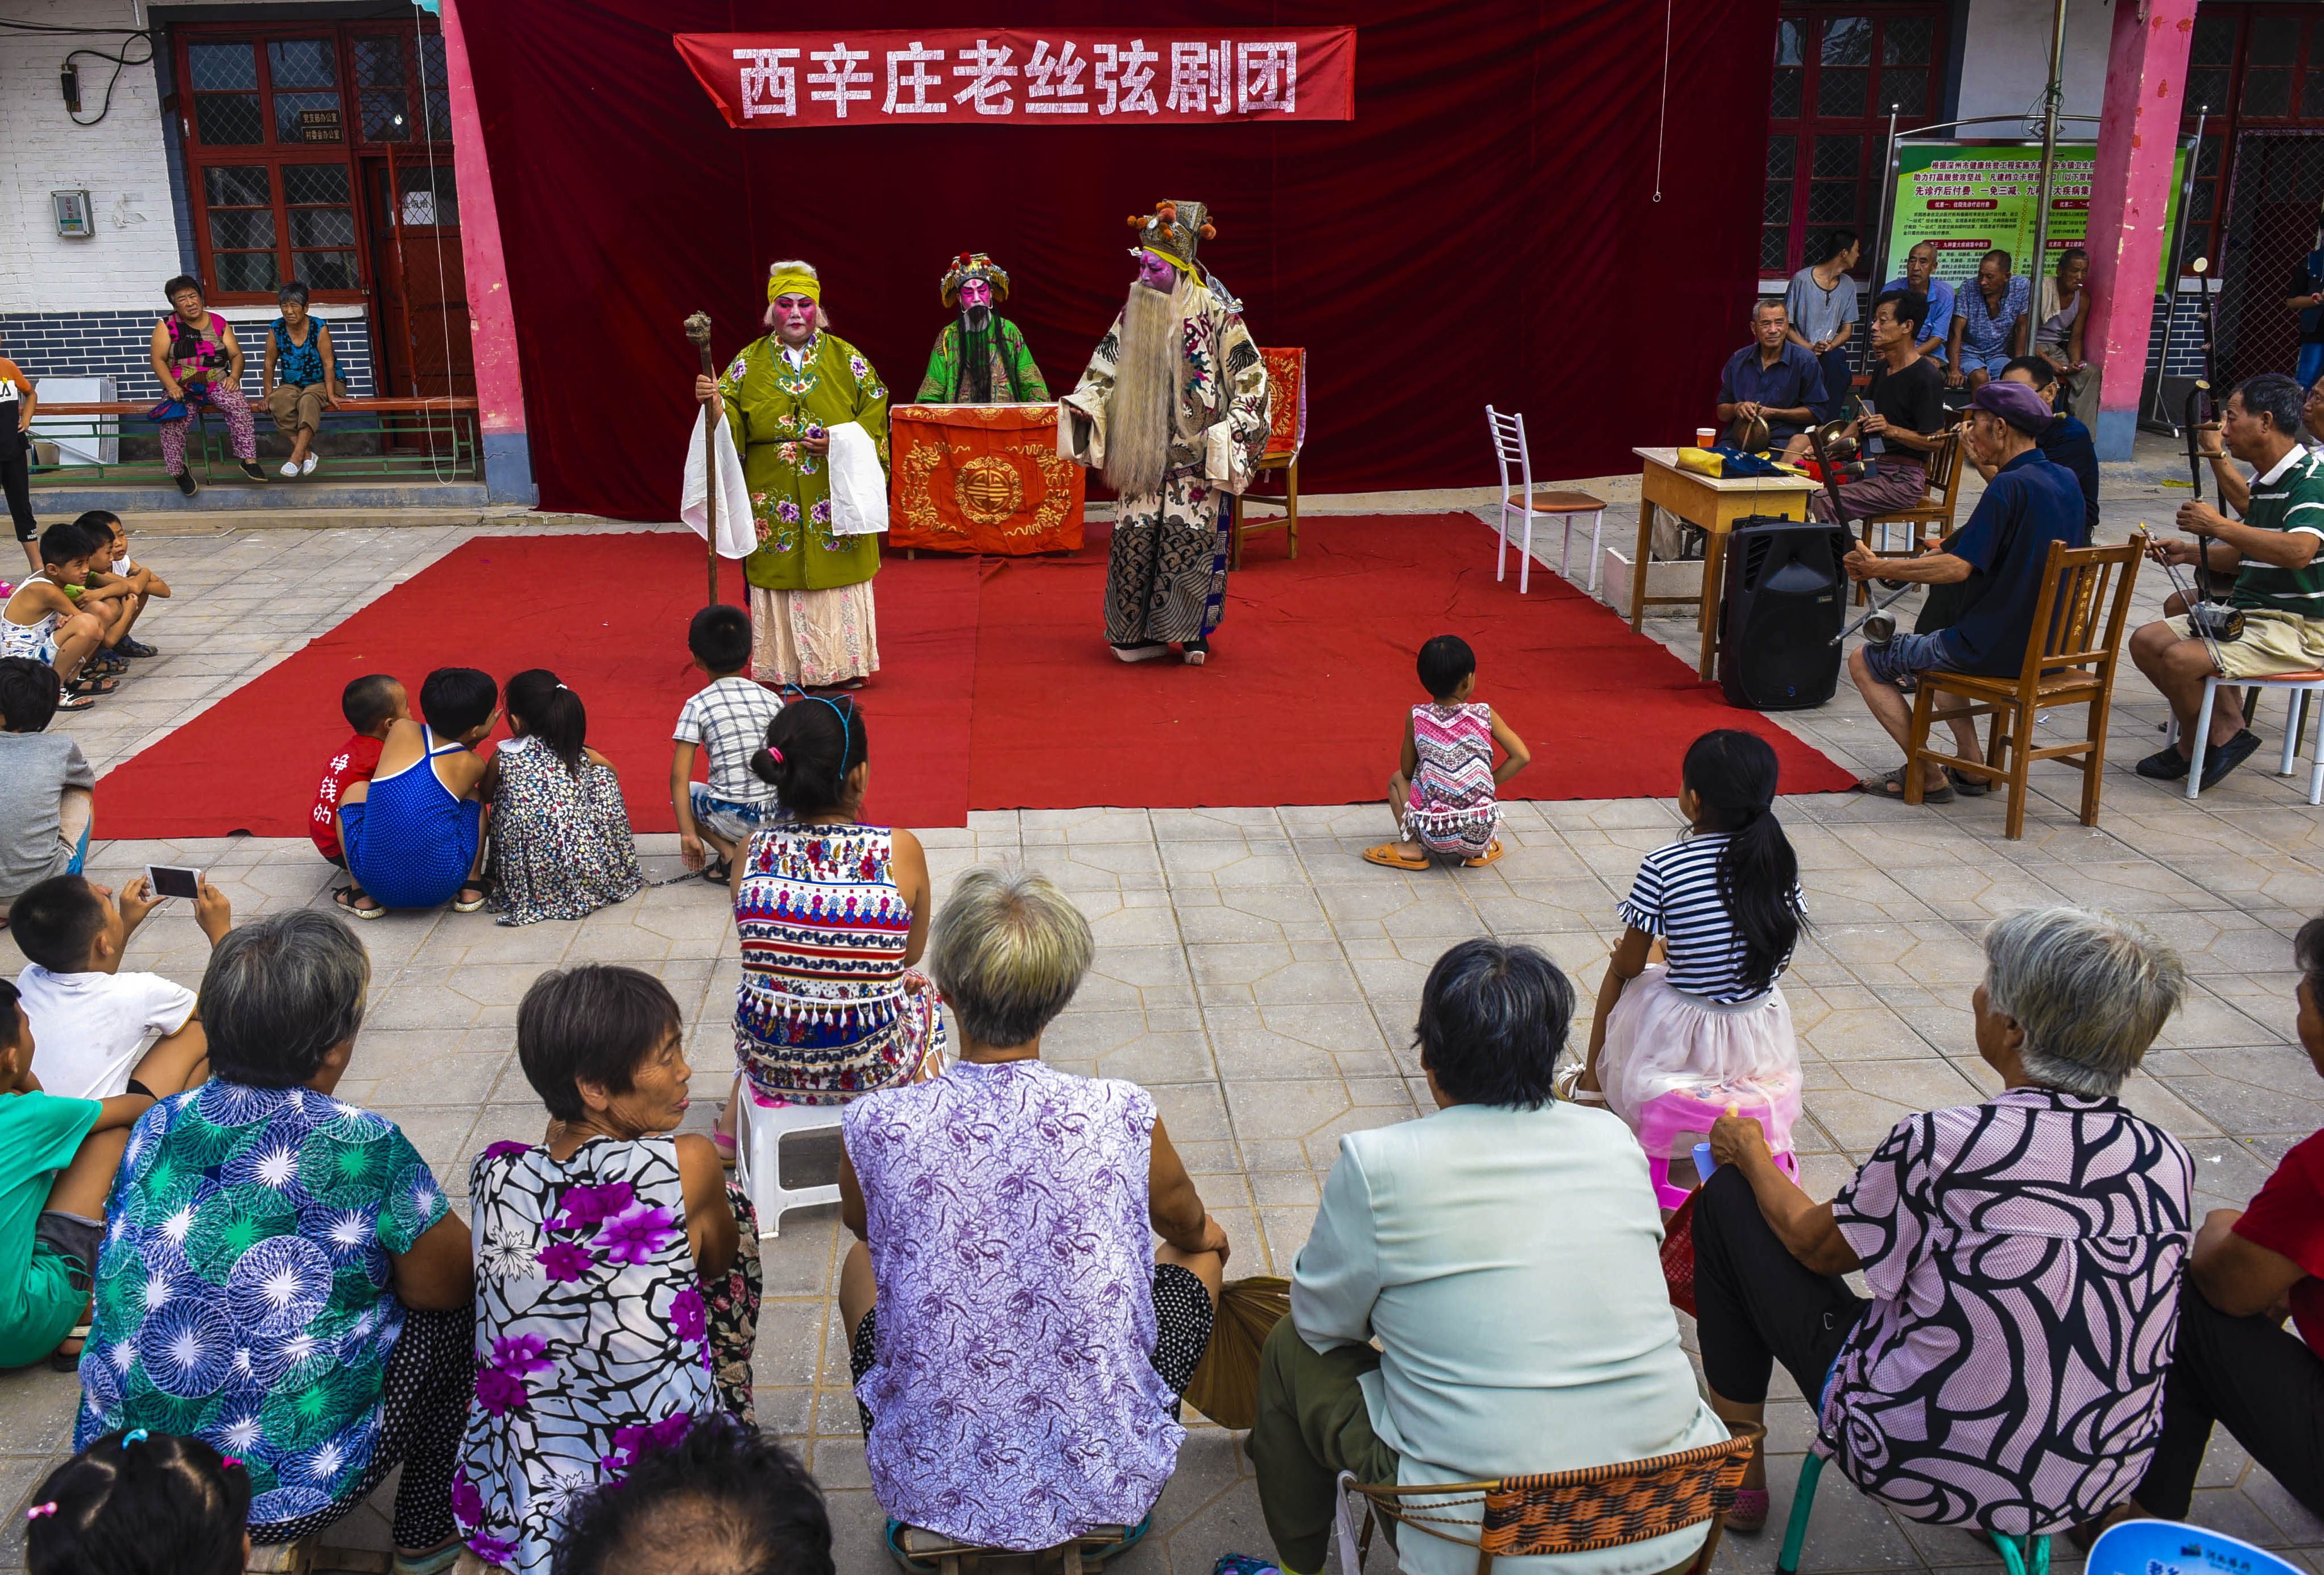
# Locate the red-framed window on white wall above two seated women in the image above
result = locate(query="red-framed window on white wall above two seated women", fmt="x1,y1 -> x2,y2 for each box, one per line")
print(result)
172,19 -> 458,304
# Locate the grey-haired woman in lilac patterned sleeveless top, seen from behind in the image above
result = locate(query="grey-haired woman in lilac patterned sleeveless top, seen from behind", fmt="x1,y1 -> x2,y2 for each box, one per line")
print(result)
839,869 -> 1227,1549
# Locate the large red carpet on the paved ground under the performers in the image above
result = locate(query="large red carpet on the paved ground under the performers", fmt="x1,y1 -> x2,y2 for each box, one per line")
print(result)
98,514 -> 1855,836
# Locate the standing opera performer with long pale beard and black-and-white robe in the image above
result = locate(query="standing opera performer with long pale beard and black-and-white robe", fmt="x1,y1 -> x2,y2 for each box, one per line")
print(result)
1057,200 -> 1269,667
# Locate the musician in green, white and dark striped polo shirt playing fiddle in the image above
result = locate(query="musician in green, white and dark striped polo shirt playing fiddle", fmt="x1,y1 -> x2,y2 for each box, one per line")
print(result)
2131,371 -> 2324,788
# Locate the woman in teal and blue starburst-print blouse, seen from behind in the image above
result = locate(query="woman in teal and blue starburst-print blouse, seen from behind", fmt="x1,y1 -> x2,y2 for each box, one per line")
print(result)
75,908 -> 474,1575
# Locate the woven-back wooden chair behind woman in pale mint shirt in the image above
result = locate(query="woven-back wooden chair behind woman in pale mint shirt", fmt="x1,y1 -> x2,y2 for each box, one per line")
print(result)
1339,1421 -> 1764,1575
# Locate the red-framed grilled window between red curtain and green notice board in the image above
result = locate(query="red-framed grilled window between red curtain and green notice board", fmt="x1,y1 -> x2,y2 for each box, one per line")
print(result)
1759,0 -> 1945,276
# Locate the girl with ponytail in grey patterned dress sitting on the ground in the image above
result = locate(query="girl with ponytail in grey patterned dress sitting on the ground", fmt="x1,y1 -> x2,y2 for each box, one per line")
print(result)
486,667 -> 646,924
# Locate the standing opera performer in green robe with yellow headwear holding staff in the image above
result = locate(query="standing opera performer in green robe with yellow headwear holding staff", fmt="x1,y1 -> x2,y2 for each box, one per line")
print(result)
695,260 -> 888,690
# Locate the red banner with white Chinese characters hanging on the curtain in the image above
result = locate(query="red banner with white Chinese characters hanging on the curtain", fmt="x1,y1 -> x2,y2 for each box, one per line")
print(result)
674,28 -> 1355,128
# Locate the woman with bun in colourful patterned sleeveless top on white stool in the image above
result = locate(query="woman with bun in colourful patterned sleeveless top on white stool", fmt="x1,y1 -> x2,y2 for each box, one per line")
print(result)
718,695 -> 944,1138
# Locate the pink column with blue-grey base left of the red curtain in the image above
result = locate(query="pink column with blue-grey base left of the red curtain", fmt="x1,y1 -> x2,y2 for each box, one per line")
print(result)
444,0 -> 539,504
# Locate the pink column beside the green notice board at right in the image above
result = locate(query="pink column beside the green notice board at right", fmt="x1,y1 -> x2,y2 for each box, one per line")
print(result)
2085,0 -> 2196,460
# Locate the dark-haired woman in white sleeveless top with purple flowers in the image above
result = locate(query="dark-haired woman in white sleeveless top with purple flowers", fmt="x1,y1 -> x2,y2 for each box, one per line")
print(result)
451,966 -> 758,1575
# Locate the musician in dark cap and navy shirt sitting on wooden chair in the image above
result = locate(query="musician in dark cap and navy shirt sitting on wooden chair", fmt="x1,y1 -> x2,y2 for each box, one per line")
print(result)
1845,383 -> 2082,804
